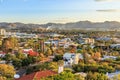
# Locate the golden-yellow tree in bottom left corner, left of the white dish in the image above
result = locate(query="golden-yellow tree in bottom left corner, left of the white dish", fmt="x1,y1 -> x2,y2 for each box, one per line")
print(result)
0,64 -> 15,80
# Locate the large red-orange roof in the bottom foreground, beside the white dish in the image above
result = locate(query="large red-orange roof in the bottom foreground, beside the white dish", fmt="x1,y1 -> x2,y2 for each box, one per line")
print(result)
16,70 -> 57,80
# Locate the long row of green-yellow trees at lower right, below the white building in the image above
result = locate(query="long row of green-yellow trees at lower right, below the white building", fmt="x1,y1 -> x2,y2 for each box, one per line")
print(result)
73,64 -> 115,73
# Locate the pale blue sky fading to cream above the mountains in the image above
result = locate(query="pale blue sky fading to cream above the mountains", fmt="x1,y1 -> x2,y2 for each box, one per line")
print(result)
0,0 -> 120,24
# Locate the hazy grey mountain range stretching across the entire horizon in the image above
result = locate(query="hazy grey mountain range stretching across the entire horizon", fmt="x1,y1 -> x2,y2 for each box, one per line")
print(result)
0,21 -> 120,31
